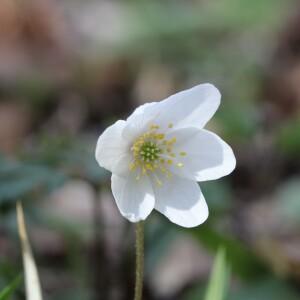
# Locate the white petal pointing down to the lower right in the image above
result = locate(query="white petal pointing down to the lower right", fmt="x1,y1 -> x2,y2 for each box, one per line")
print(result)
153,176 -> 208,227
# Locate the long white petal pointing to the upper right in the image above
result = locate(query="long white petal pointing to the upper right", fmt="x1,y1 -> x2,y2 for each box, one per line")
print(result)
128,83 -> 221,128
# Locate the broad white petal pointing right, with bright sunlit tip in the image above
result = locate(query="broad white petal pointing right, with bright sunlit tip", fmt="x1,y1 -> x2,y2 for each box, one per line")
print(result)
167,128 -> 236,181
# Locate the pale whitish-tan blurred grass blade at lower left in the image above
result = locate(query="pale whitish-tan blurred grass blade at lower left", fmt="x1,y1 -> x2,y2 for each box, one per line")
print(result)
17,202 -> 42,300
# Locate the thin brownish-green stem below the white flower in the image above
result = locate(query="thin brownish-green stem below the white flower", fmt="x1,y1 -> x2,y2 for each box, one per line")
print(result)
134,221 -> 144,300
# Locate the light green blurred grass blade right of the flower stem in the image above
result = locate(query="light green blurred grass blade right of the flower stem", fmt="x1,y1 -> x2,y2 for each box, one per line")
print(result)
204,248 -> 229,300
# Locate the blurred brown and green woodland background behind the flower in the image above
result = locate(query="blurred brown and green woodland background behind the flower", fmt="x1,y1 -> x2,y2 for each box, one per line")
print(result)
0,0 -> 300,300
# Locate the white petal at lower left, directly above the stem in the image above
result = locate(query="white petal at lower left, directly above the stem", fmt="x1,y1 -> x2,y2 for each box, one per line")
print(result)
111,174 -> 154,222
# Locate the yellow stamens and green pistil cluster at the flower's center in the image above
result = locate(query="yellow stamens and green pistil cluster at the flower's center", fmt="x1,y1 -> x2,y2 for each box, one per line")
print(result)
129,124 -> 186,185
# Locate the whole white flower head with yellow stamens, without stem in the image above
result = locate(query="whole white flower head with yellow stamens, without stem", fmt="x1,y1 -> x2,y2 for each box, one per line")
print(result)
96,84 -> 236,227
